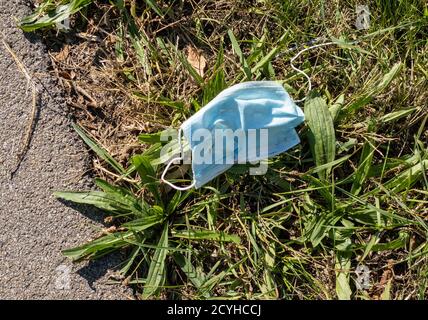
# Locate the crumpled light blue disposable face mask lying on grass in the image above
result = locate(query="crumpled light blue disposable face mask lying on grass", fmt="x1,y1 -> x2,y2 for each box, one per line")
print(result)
161,81 -> 304,190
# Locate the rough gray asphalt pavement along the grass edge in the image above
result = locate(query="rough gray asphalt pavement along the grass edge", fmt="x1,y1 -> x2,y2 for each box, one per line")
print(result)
0,0 -> 130,299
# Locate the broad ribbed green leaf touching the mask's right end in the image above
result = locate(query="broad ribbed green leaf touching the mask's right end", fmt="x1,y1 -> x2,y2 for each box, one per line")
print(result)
305,97 -> 336,180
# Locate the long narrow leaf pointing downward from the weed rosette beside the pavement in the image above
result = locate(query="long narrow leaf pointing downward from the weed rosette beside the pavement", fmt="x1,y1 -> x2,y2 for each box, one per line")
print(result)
141,223 -> 168,299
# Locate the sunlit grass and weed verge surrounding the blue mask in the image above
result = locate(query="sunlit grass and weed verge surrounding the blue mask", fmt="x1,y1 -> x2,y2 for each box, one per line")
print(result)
21,0 -> 428,299
